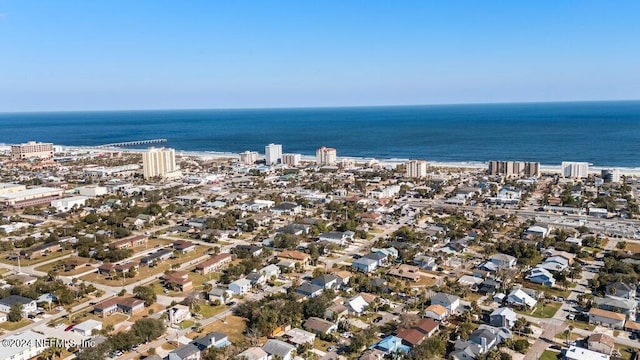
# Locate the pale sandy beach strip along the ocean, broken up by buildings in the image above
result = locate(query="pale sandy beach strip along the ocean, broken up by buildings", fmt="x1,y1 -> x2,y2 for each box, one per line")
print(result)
5,144 -> 640,176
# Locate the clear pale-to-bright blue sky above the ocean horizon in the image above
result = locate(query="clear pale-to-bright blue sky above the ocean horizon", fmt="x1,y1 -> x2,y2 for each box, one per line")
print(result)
0,0 -> 640,111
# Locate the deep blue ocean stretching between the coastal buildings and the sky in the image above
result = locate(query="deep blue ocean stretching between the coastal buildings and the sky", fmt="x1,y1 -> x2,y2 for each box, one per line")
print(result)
0,101 -> 640,167
